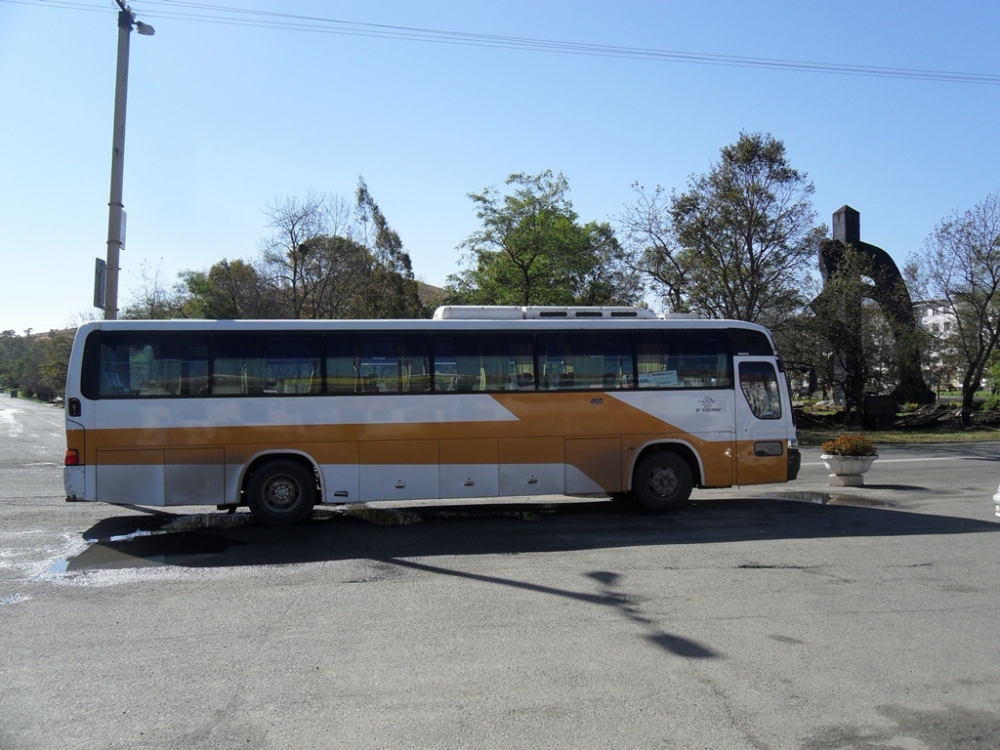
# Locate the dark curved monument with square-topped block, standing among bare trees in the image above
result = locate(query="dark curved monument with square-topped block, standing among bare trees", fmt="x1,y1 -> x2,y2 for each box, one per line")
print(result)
819,206 -> 934,417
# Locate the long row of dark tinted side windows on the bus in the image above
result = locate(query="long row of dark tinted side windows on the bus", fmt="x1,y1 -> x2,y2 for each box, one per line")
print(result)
83,329 -> 740,398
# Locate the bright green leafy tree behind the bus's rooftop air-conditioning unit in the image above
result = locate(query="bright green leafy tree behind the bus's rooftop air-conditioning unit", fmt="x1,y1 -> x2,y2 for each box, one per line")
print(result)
446,170 -> 641,305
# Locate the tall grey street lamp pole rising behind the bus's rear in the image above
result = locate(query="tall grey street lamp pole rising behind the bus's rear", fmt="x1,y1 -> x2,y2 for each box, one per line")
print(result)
104,0 -> 155,320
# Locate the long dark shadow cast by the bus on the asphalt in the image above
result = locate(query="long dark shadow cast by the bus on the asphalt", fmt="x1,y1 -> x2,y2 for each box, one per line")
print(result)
61,500 -> 1000,572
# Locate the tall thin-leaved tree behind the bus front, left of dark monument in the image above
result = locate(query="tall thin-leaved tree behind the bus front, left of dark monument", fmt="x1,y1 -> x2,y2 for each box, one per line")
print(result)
625,133 -> 826,328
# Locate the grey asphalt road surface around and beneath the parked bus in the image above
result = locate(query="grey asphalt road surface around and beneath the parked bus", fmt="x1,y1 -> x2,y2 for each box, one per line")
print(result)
0,395 -> 1000,750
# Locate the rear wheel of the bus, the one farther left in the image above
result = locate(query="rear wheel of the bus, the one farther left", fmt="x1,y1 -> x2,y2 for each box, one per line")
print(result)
247,459 -> 316,526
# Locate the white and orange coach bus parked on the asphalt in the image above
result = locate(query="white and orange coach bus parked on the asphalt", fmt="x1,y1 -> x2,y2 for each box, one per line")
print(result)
64,307 -> 800,525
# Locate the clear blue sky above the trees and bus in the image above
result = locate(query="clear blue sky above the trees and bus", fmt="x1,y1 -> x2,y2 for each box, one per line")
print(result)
0,0 -> 1000,333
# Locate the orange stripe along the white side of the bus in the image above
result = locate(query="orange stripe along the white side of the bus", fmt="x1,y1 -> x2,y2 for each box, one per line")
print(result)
67,392 -> 787,492
